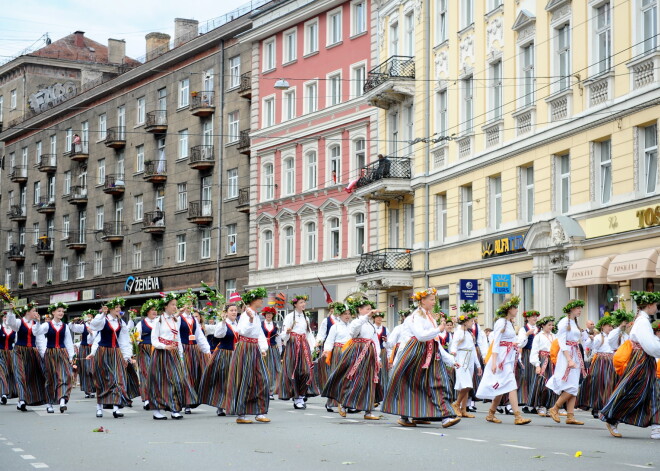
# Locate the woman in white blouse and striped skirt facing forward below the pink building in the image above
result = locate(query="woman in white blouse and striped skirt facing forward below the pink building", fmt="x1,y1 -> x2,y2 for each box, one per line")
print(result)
277,295 -> 319,409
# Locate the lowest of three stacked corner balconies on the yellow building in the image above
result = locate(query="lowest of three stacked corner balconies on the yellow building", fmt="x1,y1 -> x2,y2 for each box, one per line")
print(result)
355,249 -> 413,289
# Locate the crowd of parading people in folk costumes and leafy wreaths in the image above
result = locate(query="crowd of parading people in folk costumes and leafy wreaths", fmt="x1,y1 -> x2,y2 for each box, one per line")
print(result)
0,288 -> 660,439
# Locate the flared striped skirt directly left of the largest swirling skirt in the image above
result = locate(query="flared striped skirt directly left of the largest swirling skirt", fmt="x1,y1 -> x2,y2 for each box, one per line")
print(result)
322,339 -> 383,411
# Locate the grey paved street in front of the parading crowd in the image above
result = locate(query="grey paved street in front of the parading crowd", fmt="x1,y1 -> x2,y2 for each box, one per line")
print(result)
0,391 -> 660,471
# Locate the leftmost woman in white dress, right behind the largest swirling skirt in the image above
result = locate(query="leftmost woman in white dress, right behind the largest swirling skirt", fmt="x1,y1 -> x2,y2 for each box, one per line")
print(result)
449,309 -> 481,419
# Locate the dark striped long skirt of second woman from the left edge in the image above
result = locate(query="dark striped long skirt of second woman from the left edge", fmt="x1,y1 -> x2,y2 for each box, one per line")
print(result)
13,345 -> 46,406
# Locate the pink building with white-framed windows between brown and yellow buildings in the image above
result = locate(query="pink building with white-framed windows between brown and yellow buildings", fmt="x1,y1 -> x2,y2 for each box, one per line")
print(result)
243,0 -> 376,320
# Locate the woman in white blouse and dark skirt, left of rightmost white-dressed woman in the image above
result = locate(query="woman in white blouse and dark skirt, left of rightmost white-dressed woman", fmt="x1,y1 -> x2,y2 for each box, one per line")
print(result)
528,316 -> 557,417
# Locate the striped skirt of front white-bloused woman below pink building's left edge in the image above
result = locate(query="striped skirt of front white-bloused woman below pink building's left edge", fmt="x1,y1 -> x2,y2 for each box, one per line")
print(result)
221,338 -> 270,416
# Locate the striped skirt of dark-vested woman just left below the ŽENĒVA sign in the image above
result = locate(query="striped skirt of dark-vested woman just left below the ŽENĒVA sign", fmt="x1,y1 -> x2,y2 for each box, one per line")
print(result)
93,347 -> 131,407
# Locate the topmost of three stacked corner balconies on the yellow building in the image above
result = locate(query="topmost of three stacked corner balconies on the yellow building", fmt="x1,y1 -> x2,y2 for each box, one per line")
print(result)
363,56 -> 415,110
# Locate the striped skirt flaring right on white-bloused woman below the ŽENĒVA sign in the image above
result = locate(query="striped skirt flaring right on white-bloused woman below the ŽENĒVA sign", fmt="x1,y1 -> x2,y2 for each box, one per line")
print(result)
149,349 -> 199,412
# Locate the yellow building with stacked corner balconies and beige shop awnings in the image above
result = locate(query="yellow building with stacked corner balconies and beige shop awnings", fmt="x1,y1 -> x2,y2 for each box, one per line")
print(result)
356,0 -> 660,325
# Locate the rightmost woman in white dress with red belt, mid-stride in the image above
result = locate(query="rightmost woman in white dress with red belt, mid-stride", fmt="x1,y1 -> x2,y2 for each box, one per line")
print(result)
546,299 -> 586,425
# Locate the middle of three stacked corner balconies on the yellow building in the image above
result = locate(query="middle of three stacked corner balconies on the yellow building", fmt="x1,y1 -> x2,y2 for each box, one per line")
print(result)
355,157 -> 412,201
